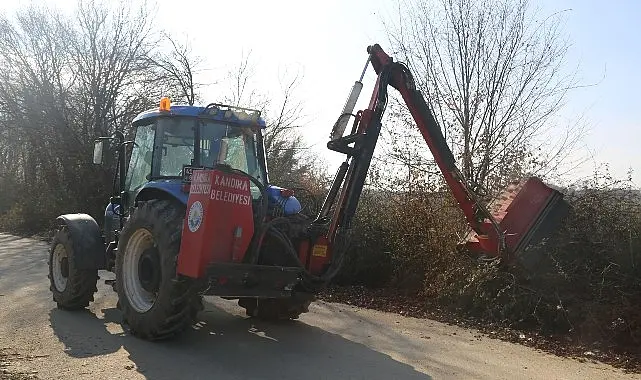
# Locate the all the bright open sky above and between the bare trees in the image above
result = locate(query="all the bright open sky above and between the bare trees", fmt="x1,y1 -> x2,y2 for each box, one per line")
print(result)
5,0 -> 641,185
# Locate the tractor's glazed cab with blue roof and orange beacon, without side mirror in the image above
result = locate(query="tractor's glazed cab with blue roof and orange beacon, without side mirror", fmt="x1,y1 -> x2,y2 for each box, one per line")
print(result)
123,98 -> 268,207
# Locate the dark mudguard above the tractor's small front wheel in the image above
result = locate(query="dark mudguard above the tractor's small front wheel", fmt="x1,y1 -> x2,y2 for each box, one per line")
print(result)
56,214 -> 106,269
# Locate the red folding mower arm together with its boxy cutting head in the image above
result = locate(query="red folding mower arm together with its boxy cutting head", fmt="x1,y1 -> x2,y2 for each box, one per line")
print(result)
348,44 -> 569,269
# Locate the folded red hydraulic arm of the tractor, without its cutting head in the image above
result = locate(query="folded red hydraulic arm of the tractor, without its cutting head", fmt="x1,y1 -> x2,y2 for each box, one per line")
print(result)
319,44 -> 504,254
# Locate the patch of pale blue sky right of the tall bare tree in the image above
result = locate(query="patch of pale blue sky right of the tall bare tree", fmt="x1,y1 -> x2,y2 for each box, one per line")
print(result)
542,0 -> 641,186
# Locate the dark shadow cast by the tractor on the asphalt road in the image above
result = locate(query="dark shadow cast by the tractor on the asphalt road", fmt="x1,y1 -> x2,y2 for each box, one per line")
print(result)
50,302 -> 430,379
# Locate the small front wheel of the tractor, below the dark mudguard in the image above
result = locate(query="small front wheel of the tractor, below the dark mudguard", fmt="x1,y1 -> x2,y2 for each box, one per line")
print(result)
49,226 -> 98,310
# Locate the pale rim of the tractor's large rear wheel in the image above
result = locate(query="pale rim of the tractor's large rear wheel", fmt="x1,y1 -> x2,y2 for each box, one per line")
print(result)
122,228 -> 161,313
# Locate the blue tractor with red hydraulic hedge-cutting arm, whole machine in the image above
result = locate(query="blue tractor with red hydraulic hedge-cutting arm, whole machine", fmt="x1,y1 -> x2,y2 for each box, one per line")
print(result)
49,44 -> 568,340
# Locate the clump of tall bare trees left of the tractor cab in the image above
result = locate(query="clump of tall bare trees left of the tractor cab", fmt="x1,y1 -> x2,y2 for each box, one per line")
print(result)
0,0 -> 200,230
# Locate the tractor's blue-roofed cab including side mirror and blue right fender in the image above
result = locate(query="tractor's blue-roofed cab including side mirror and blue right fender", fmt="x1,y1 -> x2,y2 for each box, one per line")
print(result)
94,98 -> 301,256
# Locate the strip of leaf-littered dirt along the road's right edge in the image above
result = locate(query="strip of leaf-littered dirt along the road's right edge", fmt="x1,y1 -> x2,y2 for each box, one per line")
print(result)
319,286 -> 641,373
